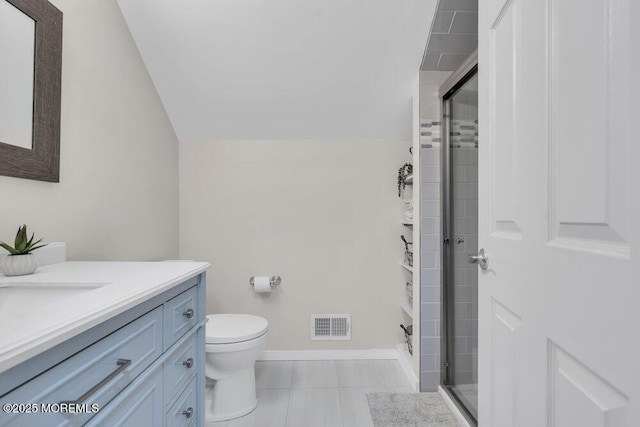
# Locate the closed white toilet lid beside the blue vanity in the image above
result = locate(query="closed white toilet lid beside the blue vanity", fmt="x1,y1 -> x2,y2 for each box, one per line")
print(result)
206,314 -> 269,344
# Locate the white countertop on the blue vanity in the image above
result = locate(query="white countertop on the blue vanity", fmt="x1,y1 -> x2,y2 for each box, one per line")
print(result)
0,261 -> 210,373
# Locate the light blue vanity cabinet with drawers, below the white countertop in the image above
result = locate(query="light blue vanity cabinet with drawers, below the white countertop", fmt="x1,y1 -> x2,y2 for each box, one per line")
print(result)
0,273 -> 206,427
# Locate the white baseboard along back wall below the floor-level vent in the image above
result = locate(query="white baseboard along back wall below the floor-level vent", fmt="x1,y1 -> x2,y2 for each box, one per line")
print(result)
258,348 -> 398,360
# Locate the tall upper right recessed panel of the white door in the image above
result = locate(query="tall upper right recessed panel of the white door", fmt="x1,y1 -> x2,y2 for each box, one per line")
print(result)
547,0 -> 632,258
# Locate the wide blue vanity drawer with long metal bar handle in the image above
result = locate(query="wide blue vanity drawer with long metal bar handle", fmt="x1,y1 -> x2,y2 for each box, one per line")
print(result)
0,307 -> 162,426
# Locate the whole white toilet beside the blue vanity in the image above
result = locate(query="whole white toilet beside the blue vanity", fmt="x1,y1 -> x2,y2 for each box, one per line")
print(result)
205,314 -> 269,421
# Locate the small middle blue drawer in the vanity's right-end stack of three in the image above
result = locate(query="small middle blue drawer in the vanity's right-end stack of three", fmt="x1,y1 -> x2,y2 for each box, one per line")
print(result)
164,331 -> 199,407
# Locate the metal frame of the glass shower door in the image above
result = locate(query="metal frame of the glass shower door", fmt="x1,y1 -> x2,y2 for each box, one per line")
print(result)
439,50 -> 478,425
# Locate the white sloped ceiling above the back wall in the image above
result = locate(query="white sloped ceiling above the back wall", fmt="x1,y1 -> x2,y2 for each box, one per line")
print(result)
118,0 -> 437,140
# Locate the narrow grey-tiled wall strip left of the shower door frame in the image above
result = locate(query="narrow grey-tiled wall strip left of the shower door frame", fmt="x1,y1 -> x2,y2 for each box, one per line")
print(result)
420,119 -> 442,391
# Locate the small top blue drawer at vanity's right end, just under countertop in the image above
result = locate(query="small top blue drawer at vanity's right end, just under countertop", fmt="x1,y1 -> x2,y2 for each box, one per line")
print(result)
164,286 -> 200,351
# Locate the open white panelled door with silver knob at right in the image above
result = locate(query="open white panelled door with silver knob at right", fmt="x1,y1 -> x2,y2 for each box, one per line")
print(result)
479,0 -> 640,427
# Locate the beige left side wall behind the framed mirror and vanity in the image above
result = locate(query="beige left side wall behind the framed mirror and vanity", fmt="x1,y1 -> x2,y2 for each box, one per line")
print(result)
0,0 -> 178,260
